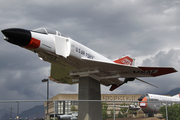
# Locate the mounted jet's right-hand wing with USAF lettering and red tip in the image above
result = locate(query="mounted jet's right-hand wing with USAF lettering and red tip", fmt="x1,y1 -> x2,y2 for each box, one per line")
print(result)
80,58 -> 177,78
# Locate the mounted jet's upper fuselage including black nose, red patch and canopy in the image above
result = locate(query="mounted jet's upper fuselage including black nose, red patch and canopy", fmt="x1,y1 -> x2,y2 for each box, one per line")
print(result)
2,28 -> 112,62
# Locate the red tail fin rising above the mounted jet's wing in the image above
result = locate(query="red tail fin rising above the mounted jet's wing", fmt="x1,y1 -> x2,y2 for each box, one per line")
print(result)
114,56 -> 134,66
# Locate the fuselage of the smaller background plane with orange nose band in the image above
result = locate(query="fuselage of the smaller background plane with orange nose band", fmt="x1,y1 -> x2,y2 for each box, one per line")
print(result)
139,94 -> 180,113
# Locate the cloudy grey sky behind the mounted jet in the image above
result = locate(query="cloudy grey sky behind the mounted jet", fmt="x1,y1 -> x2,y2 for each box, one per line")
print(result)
0,0 -> 180,100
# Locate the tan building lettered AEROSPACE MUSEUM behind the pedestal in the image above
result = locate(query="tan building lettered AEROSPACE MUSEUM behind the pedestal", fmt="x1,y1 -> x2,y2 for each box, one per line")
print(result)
44,94 -> 141,114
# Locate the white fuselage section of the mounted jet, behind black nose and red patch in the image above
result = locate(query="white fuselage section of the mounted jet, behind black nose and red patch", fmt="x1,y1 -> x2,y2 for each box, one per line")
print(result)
30,28 -> 112,62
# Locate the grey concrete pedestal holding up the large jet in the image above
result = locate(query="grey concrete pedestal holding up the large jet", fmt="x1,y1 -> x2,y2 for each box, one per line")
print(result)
78,77 -> 102,120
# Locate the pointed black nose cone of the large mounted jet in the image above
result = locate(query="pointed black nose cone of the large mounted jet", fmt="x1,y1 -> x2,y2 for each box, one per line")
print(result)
1,28 -> 31,46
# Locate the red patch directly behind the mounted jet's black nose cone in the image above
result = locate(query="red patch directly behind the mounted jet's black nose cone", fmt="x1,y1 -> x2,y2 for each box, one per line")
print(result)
26,38 -> 41,49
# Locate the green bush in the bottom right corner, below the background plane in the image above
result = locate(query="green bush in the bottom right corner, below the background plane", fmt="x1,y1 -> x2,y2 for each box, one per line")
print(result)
159,104 -> 180,120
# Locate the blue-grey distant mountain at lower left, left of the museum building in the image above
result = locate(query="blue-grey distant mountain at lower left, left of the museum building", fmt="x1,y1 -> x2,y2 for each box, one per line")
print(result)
19,105 -> 45,120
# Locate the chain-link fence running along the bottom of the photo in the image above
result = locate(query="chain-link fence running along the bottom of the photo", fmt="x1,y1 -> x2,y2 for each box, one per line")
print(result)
0,100 -> 177,120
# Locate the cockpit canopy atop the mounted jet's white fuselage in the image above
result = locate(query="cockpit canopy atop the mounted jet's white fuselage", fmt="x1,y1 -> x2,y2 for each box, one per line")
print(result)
32,28 -> 67,37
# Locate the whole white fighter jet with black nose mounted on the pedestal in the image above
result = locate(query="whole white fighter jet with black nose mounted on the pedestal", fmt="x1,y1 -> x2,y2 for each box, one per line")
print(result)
2,28 -> 177,91
